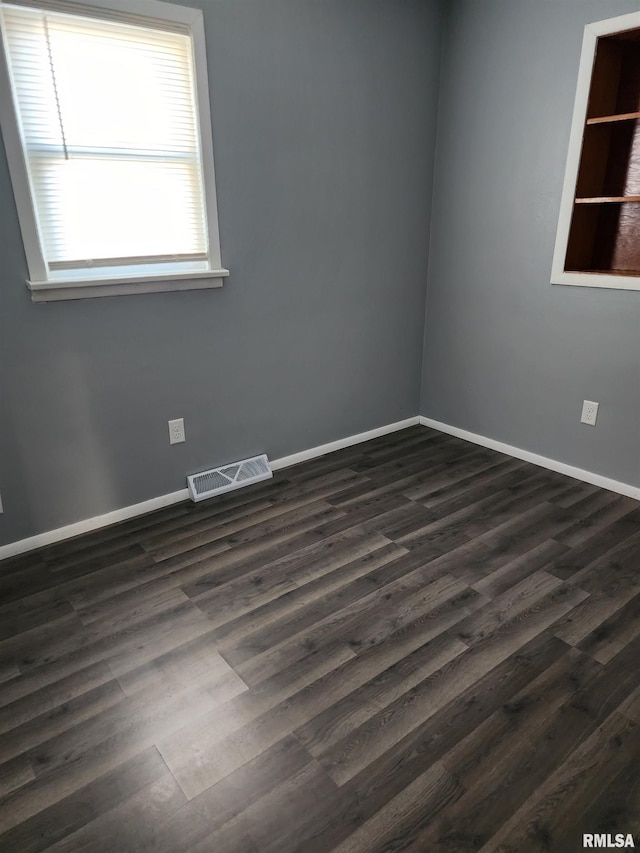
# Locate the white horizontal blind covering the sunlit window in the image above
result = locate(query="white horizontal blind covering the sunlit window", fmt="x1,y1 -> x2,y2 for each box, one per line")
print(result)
0,3 -> 209,278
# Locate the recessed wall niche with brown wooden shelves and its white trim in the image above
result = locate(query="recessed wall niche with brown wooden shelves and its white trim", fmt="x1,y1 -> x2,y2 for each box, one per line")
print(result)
551,12 -> 640,290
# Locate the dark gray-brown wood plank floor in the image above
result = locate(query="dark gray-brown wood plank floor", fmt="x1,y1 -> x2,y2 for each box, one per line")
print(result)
0,427 -> 640,853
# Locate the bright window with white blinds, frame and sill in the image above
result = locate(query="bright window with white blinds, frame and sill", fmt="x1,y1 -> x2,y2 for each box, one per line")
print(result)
0,0 -> 228,301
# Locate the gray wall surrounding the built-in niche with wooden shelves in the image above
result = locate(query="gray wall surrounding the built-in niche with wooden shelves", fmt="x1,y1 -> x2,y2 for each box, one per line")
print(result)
421,0 -> 640,486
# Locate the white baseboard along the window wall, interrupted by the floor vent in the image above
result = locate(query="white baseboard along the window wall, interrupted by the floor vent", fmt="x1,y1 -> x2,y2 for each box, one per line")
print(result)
0,415 -> 420,560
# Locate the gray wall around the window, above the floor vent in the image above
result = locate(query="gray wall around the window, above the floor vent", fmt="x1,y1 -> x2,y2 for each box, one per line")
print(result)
0,0 -> 441,544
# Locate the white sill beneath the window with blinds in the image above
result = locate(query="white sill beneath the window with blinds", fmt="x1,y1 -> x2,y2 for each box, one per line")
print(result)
27,269 -> 229,302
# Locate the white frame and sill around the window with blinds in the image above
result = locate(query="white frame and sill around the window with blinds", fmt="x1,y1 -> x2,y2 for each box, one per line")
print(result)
0,0 -> 229,302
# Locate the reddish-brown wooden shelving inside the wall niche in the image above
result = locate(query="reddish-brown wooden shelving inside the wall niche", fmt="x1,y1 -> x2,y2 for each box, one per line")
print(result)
564,27 -> 640,277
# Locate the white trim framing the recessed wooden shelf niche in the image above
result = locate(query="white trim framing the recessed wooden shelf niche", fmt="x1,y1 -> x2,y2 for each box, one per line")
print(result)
551,12 -> 640,290
